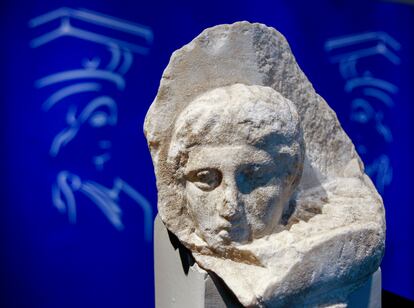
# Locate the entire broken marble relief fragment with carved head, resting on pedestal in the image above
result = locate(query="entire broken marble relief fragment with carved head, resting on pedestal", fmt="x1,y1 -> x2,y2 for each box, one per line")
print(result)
144,22 -> 385,307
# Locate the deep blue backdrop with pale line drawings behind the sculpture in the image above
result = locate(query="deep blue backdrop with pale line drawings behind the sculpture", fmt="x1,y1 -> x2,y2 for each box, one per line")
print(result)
0,0 -> 414,307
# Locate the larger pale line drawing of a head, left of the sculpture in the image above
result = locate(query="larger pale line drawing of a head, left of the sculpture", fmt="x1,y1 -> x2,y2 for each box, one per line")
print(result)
29,7 -> 154,237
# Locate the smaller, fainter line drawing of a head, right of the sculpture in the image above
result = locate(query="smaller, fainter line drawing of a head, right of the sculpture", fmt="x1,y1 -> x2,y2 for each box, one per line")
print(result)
324,31 -> 401,192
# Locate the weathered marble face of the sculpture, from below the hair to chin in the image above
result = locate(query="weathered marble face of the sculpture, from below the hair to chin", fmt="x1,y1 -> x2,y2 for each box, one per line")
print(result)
185,144 -> 292,246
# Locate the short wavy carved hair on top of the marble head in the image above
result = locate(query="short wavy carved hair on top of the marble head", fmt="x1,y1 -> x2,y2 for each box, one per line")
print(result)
173,84 -> 300,153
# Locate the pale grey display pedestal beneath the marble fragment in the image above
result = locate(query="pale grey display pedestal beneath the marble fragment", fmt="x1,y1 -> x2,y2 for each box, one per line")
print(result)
154,216 -> 381,308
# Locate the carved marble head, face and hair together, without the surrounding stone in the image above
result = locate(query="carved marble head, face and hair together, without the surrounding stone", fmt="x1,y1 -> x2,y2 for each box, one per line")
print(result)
168,84 -> 304,250
